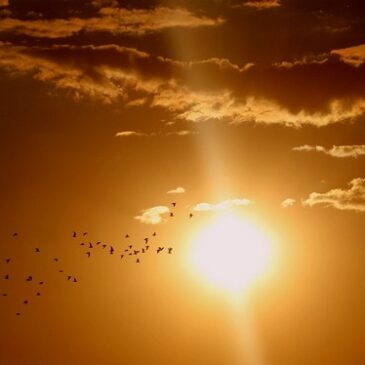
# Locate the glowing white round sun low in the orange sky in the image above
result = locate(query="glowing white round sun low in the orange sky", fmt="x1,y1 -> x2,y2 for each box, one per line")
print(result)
192,215 -> 271,293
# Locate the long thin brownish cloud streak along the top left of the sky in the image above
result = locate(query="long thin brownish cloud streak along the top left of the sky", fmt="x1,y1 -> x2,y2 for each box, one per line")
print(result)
0,7 -> 224,38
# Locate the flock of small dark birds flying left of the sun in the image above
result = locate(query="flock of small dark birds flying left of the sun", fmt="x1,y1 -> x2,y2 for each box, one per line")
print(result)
0,202 -> 193,316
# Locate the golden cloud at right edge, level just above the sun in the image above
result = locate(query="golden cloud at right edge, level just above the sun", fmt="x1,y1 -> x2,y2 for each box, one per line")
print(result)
303,178 -> 365,212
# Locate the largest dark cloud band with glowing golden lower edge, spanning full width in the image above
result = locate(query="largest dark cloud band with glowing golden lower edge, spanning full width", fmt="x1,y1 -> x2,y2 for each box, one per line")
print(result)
0,43 -> 365,126
